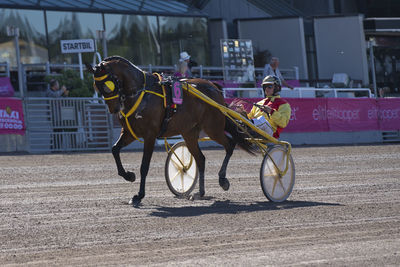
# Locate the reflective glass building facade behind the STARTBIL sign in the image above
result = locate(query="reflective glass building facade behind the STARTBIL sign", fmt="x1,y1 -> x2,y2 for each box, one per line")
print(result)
0,4 -> 209,67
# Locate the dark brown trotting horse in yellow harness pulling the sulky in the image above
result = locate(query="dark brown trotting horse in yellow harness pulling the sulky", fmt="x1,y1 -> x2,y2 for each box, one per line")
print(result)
85,56 -> 252,206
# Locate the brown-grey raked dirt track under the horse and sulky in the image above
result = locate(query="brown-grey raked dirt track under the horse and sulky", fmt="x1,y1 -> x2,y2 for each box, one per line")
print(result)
0,144 -> 400,266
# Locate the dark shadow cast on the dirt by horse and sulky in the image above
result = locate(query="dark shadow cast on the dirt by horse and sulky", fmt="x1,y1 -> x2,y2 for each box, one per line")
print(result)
149,200 -> 342,218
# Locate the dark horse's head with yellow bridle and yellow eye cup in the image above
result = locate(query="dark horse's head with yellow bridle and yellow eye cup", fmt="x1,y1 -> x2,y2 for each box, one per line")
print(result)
85,56 -> 144,113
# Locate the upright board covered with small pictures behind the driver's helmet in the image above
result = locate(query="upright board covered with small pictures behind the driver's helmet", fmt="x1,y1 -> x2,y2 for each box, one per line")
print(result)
220,39 -> 255,83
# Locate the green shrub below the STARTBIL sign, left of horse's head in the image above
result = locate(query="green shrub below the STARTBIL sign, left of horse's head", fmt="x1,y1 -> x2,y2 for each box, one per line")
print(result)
45,69 -> 94,97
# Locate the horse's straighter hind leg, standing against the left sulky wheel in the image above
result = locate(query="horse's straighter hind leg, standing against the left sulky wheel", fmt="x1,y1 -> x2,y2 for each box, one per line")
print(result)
182,130 -> 206,197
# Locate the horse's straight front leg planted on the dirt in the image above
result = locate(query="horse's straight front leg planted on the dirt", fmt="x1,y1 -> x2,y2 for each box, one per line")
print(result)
132,138 -> 156,206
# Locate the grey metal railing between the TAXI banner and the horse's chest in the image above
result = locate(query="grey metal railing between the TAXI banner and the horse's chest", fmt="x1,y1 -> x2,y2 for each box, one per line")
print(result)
24,97 -> 112,153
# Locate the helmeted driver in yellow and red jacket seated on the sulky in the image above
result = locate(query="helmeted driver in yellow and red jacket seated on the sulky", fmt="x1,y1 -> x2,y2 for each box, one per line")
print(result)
239,75 -> 292,138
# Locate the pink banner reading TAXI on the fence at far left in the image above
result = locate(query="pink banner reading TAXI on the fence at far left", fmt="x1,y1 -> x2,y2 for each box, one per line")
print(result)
0,97 -> 25,135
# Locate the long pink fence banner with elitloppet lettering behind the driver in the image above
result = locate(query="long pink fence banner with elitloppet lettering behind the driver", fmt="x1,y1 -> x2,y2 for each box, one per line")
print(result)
226,98 -> 400,132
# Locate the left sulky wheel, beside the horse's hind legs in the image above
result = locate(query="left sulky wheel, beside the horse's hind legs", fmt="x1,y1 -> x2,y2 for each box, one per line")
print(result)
165,141 -> 199,197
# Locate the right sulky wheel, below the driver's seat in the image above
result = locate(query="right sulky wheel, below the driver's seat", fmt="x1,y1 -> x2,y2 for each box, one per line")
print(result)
260,146 -> 295,202
